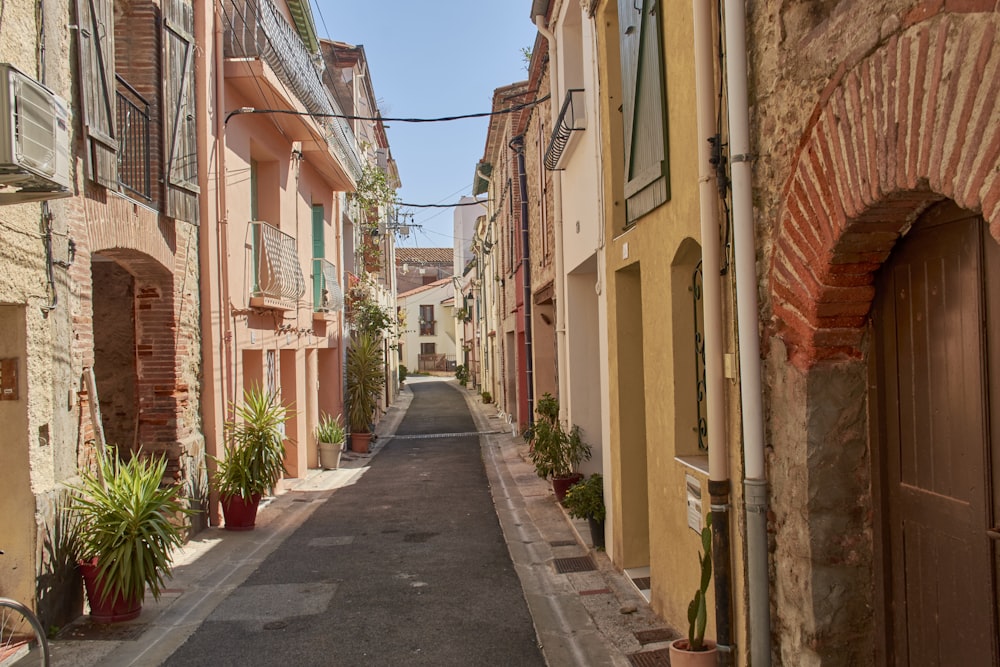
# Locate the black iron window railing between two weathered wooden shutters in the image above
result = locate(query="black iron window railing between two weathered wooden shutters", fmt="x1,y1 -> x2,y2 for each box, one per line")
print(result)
115,75 -> 153,201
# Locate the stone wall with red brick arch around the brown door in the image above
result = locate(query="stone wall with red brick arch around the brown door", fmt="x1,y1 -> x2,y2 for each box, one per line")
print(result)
748,0 -> 1000,665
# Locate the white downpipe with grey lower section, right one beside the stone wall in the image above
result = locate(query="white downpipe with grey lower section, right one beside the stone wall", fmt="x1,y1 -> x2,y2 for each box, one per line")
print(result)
725,0 -> 771,667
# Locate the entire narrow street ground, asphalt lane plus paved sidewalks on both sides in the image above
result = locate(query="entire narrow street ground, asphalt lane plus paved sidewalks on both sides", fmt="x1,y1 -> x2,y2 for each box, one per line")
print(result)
53,378 -> 662,667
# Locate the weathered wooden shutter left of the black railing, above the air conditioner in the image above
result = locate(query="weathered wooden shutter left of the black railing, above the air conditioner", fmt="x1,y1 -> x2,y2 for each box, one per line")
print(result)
76,0 -> 118,190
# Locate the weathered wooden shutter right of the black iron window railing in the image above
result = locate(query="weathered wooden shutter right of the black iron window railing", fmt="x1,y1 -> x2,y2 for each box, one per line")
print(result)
163,0 -> 199,223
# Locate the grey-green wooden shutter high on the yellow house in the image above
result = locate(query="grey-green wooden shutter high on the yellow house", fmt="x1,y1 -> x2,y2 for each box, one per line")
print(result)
618,0 -> 670,224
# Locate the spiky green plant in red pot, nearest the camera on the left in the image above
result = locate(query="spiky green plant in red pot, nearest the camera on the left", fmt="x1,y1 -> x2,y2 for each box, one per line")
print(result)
68,451 -> 194,623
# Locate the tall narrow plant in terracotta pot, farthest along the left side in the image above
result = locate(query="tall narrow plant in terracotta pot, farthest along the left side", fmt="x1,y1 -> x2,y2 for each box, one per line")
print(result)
346,331 -> 385,453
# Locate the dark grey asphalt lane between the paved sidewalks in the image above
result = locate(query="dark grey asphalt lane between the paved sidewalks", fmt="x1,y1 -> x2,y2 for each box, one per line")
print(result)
160,382 -> 545,667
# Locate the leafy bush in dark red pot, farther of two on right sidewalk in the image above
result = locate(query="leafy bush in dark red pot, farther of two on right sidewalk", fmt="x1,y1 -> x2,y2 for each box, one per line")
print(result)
524,393 -> 590,502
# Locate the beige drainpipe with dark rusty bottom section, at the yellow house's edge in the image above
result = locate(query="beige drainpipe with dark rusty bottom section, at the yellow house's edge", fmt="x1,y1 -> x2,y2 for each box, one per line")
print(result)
693,0 -> 732,665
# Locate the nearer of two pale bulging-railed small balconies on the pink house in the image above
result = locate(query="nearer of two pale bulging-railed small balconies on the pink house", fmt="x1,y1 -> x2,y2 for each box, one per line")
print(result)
250,221 -> 306,310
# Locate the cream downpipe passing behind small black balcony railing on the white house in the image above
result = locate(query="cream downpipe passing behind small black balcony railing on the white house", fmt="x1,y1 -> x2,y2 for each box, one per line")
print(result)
532,13 -> 569,422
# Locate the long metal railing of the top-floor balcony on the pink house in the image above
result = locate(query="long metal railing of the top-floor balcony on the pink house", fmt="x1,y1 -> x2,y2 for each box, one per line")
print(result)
224,0 -> 361,180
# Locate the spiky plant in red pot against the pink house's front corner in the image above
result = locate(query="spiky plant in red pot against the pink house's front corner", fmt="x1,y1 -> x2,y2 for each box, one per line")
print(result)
213,387 -> 288,530
